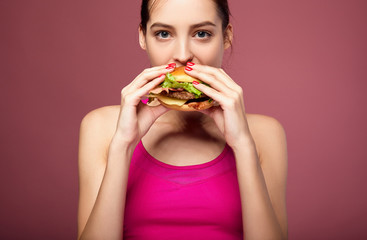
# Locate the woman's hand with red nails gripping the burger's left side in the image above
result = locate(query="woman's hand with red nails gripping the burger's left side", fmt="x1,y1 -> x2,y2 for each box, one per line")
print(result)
115,64 -> 175,147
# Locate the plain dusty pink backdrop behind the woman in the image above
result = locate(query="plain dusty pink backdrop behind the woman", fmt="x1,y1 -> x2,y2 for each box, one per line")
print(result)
0,0 -> 367,240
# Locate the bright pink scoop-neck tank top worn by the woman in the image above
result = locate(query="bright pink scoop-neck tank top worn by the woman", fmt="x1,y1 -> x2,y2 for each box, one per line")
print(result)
124,142 -> 243,240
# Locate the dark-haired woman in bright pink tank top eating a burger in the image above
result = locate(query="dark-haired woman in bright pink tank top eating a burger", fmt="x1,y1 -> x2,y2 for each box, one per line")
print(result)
78,0 -> 287,239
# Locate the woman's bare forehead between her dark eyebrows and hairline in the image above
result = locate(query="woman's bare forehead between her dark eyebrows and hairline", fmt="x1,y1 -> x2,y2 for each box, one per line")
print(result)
148,0 -> 221,25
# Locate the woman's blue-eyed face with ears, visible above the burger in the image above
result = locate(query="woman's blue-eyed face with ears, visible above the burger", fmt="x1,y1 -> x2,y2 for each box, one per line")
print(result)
139,0 -> 232,67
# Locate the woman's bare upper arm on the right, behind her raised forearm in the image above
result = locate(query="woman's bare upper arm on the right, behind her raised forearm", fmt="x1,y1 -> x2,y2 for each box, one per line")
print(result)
253,116 -> 288,235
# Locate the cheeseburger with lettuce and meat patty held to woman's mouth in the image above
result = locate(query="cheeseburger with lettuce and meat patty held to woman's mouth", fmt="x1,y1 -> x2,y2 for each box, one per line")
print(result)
148,66 -> 213,111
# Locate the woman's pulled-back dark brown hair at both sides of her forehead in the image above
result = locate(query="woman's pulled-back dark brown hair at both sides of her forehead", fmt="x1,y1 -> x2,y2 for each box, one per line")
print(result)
140,0 -> 231,34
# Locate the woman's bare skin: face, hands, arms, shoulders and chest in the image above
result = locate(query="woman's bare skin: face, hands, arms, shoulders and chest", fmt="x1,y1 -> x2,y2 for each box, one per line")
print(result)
78,0 -> 287,239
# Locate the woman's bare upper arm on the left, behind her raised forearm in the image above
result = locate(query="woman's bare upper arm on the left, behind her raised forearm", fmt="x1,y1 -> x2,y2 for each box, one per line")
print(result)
78,108 -> 118,236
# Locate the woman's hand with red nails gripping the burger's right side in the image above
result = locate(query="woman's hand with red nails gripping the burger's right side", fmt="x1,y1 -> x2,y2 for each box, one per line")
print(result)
185,64 -> 252,147
